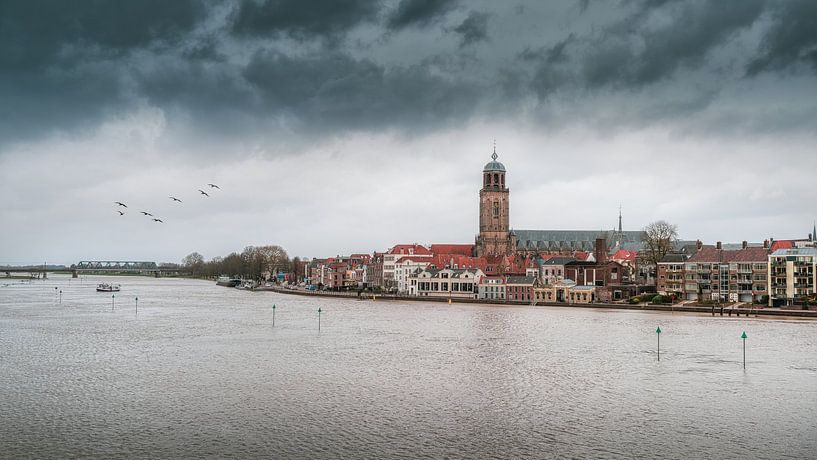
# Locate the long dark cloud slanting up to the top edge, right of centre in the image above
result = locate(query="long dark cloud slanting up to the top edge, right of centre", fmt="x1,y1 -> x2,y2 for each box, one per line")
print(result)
520,0 -> 764,95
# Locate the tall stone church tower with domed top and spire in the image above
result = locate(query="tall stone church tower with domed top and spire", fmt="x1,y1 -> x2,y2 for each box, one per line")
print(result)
476,145 -> 515,257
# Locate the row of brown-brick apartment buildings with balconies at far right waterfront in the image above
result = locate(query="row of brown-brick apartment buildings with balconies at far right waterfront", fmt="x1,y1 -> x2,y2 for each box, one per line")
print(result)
657,240 -> 817,306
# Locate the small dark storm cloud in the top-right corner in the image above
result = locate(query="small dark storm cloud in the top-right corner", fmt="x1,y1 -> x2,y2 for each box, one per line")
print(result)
747,0 -> 817,75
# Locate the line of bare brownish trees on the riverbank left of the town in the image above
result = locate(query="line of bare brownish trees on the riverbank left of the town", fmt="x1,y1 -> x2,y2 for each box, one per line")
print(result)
181,245 -> 303,280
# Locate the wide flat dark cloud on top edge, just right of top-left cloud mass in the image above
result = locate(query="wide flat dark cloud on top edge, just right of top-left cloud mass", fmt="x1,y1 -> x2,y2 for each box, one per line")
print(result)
232,0 -> 381,39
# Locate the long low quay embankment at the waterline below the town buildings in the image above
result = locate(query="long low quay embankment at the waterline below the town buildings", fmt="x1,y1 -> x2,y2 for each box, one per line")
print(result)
256,286 -> 817,319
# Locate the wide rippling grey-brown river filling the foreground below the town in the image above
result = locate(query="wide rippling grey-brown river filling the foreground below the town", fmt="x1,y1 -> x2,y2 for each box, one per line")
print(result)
0,277 -> 817,458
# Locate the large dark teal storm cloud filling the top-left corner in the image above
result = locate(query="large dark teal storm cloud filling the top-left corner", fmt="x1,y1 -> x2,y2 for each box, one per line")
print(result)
0,0 -> 206,143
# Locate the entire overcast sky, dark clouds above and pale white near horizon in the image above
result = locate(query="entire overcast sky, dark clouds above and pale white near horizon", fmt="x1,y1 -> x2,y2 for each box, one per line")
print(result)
0,0 -> 817,264
